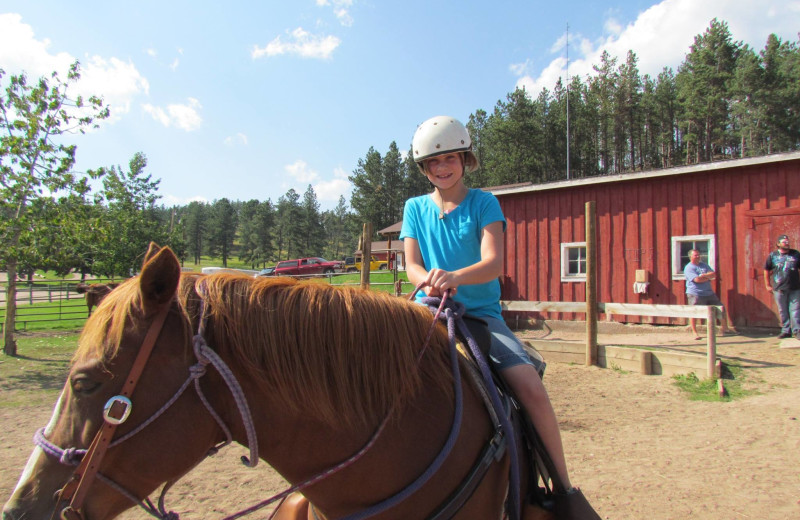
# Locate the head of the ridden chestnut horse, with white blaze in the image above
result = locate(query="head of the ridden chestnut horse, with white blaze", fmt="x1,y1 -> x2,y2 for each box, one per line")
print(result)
3,244 -> 221,520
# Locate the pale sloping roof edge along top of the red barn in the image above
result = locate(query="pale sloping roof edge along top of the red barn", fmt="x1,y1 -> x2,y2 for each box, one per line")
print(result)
483,152 -> 800,197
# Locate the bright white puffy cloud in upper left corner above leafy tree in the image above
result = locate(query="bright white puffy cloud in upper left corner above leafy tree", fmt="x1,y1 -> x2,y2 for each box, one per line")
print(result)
0,13 -> 150,121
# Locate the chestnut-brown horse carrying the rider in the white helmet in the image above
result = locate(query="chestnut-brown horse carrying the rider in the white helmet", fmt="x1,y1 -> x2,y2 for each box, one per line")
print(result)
3,245 -> 536,520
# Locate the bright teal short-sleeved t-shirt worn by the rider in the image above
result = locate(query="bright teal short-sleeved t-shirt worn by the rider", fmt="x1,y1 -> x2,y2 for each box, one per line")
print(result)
400,189 -> 506,319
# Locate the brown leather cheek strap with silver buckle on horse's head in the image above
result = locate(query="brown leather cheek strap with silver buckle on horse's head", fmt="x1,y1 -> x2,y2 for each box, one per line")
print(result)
59,302 -> 170,520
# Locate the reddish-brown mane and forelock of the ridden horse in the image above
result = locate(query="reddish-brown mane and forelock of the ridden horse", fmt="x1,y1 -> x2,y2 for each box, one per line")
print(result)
76,273 -> 452,428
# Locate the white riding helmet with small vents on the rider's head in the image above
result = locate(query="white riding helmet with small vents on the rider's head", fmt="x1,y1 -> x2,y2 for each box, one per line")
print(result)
411,116 -> 480,174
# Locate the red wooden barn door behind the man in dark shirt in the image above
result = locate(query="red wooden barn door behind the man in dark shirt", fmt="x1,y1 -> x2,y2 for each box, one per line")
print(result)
745,208 -> 800,327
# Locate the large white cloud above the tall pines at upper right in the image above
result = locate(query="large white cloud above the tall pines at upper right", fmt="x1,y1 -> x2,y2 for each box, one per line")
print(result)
516,0 -> 800,97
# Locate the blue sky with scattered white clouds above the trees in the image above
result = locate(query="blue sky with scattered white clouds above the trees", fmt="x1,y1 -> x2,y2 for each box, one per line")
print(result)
0,0 -> 800,209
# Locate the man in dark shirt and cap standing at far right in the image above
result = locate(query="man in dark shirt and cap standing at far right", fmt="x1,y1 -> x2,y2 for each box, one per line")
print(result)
764,235 -> 800,339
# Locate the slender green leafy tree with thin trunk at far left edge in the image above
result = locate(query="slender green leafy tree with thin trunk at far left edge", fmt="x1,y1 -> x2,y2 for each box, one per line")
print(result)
0,62 -> 108,355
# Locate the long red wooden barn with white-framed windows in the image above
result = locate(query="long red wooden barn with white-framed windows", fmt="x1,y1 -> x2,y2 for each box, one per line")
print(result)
487,152 -> 800,327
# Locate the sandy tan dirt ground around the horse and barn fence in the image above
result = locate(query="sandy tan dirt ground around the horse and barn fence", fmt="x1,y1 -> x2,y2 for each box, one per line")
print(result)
0,326 -> 800,520
